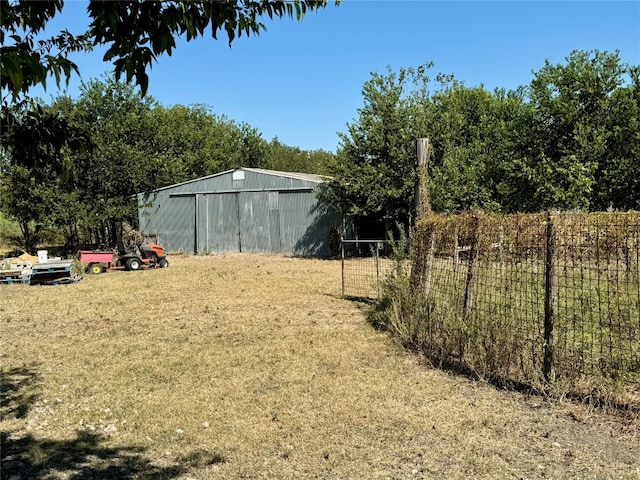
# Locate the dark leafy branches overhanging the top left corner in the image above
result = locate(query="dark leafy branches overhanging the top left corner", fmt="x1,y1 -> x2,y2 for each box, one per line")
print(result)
0,0 -> 337,103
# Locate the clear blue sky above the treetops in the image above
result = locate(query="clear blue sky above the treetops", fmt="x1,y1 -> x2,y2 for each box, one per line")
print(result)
32,0 -> 640,151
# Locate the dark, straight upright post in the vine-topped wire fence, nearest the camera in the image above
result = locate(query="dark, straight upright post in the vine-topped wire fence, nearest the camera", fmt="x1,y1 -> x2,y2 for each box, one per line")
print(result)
542,211 -> 558,382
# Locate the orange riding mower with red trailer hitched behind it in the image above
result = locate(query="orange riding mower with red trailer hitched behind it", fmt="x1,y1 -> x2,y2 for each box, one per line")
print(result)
76,243 -> 169,274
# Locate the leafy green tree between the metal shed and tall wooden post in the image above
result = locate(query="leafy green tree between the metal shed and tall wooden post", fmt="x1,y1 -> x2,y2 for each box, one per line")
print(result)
321,65 -> 431,235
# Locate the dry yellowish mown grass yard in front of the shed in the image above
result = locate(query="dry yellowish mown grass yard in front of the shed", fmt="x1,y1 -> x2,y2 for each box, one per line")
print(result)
0,255 -> 640,480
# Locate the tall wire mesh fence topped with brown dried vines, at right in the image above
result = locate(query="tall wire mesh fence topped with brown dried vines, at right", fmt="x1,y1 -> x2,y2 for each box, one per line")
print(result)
411,212 -> 640,394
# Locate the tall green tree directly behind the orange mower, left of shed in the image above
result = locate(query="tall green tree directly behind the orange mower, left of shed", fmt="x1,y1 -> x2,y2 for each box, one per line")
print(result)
65,80 -> 157,244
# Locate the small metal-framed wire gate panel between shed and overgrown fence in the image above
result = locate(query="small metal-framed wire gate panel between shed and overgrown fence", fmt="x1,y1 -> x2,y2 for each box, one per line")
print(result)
341,239 -> 392,299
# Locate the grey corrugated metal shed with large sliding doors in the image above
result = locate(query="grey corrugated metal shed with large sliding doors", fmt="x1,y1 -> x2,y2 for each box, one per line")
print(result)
138,168 -> 342,257
